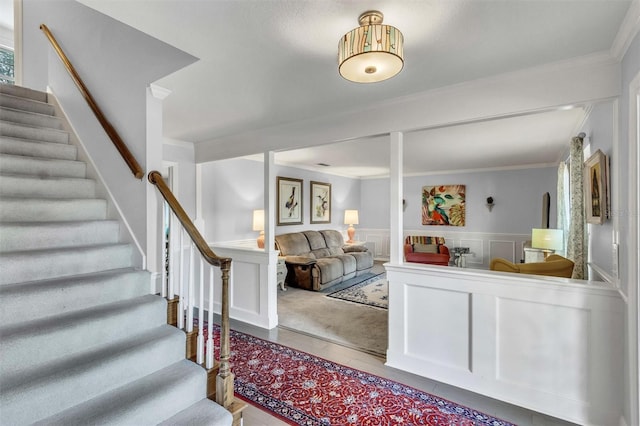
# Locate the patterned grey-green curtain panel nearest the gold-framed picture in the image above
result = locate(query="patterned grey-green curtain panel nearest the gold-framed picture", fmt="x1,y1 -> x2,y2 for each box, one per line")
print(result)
567,136 -> 587,280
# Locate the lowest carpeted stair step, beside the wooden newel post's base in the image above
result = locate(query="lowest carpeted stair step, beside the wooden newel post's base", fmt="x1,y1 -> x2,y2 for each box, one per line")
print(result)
36,360 -> 231,426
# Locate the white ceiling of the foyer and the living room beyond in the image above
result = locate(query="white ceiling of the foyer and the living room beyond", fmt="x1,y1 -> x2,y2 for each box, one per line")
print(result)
0,0 -> 631,176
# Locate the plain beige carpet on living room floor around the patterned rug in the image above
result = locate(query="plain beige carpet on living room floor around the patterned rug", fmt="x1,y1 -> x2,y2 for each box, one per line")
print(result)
278,266 -> 388,358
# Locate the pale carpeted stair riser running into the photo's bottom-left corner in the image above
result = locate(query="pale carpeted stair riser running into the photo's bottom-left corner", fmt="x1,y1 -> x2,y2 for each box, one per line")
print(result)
0,330 -> 184,424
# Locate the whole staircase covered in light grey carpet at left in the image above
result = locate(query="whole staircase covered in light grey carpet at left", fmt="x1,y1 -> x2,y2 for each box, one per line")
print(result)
0,85 -> 232,425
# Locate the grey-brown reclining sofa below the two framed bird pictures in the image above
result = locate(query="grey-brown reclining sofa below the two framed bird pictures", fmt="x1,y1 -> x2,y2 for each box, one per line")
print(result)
275,230 -> 373,291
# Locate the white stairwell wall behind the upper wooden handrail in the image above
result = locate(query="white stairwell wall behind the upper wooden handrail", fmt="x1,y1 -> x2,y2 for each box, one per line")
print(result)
22,0 -> 196,251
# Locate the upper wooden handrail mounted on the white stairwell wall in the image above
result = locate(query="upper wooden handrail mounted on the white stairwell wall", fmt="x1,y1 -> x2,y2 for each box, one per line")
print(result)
40,24 -> 144,179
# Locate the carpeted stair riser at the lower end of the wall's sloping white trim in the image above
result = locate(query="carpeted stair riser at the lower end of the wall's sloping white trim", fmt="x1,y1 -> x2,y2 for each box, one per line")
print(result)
0,244 -> 132,285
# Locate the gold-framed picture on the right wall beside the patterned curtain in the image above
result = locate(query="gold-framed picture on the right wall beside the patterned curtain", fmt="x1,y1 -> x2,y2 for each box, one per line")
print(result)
584,150 -> 609,225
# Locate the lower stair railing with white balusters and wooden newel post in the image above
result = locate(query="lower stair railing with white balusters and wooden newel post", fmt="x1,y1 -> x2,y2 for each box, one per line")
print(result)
148,170 -> 234,408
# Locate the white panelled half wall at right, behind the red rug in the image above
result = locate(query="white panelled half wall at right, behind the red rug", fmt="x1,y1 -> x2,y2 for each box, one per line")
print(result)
386,262 -> 625,425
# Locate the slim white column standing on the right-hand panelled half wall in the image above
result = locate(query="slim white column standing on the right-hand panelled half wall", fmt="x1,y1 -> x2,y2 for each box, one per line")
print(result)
389,132 -> 404,264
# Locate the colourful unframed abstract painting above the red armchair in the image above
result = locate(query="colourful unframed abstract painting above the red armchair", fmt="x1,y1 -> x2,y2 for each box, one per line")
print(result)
422,185 -> 465,226
